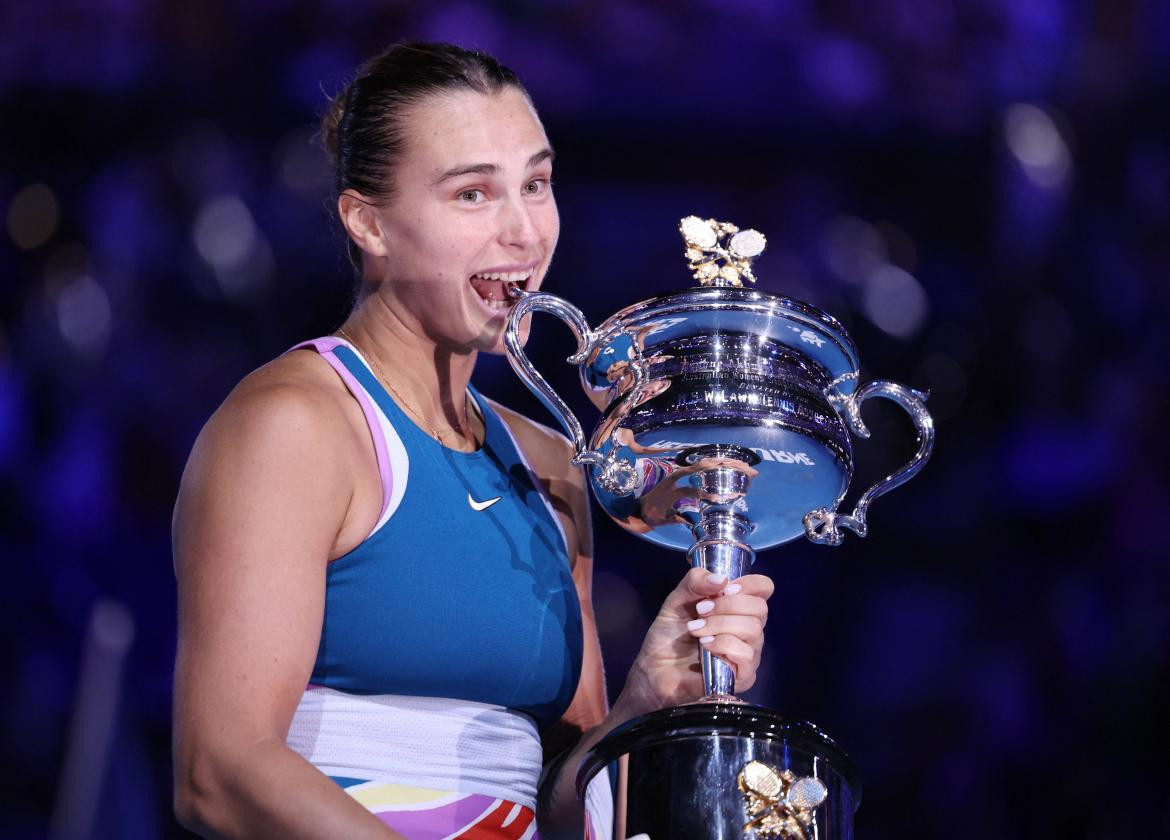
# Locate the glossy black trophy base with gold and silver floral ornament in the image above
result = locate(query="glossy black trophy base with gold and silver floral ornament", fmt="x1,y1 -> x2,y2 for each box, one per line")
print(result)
577,701 -> 861,840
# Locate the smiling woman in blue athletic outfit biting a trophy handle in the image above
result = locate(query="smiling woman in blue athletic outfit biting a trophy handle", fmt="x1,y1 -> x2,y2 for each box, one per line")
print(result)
174,43 -> 771,840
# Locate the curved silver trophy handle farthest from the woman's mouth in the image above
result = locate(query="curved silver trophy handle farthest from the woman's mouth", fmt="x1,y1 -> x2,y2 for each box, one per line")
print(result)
804,379 -> 935,545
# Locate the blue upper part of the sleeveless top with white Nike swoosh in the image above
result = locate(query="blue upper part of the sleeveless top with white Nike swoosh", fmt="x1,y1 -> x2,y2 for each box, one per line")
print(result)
311,345 -> 583,728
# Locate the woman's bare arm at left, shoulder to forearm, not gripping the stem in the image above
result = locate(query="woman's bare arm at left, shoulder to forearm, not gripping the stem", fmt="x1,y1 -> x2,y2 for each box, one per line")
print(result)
173,372 -> 399,838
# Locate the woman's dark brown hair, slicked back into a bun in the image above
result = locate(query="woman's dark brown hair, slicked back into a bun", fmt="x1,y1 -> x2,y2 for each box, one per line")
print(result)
321,41 -> 528,270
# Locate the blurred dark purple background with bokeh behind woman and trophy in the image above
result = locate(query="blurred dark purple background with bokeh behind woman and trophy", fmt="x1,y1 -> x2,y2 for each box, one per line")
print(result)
0,0 -> 1170,840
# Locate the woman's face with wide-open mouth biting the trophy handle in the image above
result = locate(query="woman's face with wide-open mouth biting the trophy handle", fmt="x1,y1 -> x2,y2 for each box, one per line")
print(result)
360,87 -> 560,352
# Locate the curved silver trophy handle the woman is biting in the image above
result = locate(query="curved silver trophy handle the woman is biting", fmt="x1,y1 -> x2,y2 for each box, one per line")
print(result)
504,289 -> 636,496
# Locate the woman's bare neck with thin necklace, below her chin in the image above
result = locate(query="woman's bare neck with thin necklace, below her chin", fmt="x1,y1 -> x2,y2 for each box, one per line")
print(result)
340,294 -> 477,439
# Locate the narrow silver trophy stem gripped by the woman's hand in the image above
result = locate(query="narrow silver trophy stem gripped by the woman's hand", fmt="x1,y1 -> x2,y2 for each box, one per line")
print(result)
687,503 -> 756,702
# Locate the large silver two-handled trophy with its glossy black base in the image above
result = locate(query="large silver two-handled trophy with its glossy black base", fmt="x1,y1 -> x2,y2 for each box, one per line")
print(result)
504,216 -> 934,840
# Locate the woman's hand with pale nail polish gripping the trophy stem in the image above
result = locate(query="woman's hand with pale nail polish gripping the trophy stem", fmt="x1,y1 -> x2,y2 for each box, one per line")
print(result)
617,569 -> 775,715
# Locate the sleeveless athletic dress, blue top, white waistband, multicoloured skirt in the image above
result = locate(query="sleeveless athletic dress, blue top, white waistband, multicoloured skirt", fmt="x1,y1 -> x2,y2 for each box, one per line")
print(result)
288,337 -> 613,840
